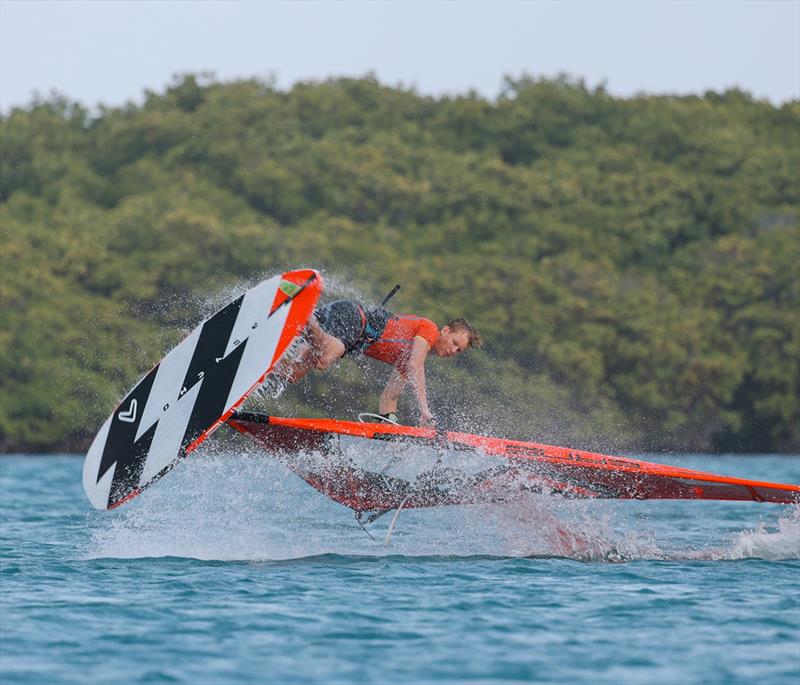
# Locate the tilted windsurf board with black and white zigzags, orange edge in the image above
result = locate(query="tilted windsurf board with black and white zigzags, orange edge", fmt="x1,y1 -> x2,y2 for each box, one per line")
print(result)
83,269 -> 323,509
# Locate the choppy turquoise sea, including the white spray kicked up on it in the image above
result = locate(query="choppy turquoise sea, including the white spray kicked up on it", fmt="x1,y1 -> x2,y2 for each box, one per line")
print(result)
0,448 -> 800,685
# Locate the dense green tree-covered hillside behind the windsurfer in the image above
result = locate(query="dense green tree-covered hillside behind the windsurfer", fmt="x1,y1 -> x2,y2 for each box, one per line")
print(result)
0,76 -> 800,451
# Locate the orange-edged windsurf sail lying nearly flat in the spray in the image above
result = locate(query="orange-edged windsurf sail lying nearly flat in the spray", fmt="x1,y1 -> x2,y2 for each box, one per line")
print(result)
228,413 -> 800,511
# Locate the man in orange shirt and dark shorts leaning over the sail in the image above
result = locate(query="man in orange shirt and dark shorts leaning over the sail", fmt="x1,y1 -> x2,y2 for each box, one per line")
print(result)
288,300 -> 483,426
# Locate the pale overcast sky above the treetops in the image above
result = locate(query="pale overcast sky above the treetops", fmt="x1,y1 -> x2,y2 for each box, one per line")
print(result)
0,0 -> 800,112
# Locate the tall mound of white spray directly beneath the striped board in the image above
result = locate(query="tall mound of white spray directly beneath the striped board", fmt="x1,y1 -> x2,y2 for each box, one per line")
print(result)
87,448 -> 350,561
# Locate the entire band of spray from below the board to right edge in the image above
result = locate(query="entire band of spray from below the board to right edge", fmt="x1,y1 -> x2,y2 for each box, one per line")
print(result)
87,440 -> 800,563
